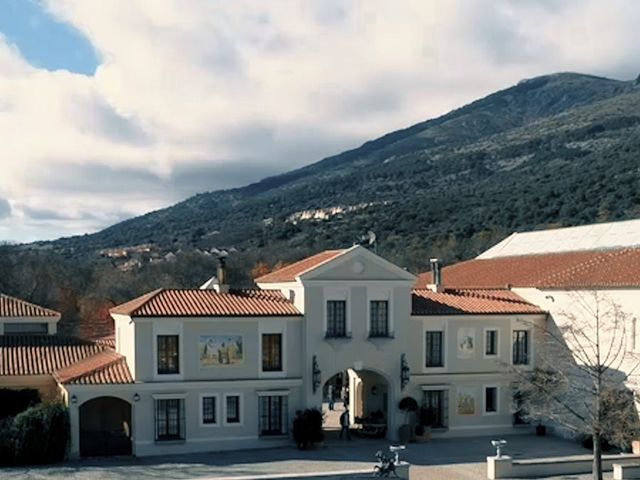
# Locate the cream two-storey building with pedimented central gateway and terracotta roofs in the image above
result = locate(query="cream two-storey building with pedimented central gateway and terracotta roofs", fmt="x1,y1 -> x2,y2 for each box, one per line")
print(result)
6,246 -> 546,456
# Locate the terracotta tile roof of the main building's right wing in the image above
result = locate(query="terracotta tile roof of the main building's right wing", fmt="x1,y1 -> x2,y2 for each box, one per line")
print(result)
411,289 -> 545,315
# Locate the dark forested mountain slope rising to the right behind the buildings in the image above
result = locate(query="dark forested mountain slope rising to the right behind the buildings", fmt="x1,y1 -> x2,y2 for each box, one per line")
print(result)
28,73 -> 640,271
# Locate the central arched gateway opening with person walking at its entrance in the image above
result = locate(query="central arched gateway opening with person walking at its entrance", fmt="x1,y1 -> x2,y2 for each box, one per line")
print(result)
322,368 -> 390,438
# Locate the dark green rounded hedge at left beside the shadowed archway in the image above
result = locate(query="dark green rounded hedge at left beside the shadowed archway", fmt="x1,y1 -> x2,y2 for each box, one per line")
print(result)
0,404 -> 70,465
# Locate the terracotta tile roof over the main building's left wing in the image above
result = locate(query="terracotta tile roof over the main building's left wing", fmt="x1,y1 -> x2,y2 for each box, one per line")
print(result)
111,289 -> 302,317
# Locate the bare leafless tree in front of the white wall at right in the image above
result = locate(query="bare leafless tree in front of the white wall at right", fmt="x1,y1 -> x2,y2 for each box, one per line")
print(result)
512,292 -> 640,480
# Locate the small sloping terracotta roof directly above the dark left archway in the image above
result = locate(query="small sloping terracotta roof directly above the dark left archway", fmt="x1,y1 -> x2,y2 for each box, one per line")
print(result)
53,350 -> 133,385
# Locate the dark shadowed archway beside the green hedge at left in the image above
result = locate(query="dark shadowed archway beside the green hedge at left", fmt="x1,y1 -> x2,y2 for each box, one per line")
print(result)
80,397 -> 131,457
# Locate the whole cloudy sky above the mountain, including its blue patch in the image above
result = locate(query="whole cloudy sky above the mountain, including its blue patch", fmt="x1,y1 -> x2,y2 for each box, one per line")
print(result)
0,0 -> 640,242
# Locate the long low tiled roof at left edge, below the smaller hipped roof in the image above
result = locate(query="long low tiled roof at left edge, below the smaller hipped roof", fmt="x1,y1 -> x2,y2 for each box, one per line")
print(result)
0,335 -> 106,376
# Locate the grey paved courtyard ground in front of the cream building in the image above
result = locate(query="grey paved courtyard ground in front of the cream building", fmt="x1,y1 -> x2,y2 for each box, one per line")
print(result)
0,435 -> 610,480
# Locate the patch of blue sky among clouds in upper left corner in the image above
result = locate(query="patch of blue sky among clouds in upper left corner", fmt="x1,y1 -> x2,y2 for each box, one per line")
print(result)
0,0 -> 99,75
